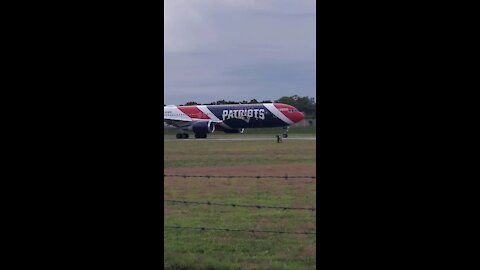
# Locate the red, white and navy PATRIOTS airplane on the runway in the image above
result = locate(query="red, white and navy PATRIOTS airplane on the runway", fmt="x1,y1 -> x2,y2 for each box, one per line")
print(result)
163,103 -> 305,139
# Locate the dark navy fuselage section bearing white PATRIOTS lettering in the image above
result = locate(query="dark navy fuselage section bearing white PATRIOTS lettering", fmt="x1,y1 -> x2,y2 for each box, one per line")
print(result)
207,104 -> 287,128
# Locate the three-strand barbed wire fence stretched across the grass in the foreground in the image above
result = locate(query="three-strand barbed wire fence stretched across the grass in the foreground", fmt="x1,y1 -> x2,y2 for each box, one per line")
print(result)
163,174 -> 317,235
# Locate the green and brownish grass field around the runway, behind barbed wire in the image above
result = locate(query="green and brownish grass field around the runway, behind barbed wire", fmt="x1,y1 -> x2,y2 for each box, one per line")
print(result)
164,129 -> 316,269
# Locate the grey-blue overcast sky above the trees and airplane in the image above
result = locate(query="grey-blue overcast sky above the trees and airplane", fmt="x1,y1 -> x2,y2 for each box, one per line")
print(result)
163,0 -> 316,105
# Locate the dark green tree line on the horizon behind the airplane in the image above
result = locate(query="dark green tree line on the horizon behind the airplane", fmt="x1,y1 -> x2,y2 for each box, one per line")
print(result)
164,95 -> 317,118
